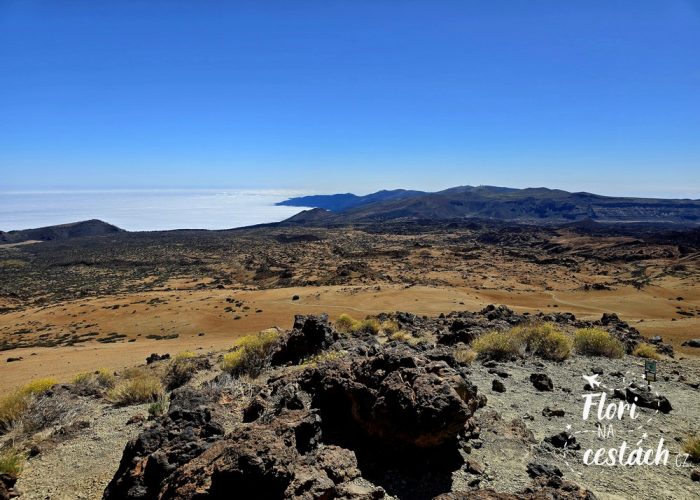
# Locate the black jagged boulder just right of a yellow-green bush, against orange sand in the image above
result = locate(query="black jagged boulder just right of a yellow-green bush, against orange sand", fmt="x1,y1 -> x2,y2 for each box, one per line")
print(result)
272,314 -> 338,365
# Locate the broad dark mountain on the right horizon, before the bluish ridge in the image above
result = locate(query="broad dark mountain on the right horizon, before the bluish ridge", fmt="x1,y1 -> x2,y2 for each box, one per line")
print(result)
278,186 -> 700,225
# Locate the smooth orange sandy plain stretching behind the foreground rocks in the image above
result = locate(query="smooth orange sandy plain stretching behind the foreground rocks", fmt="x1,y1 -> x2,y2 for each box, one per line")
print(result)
0,285 -> 700,393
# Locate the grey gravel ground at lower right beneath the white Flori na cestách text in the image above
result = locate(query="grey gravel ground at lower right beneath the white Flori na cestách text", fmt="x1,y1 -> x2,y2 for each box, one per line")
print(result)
454,356 -> 700,500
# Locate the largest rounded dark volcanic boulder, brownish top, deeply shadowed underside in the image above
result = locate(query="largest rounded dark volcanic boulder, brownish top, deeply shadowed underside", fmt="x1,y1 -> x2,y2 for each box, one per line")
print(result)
299,349 -> 479,448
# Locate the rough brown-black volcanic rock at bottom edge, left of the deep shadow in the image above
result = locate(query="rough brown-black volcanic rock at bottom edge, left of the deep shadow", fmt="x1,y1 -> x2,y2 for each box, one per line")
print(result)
160,410 -> 384,500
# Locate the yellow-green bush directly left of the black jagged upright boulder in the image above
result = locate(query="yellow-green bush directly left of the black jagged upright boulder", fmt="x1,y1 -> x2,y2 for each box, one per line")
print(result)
221,329 -> 280,377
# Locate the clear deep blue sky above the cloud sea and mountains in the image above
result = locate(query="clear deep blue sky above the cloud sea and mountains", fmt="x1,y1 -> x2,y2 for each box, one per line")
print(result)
0,0 -> 700,198
